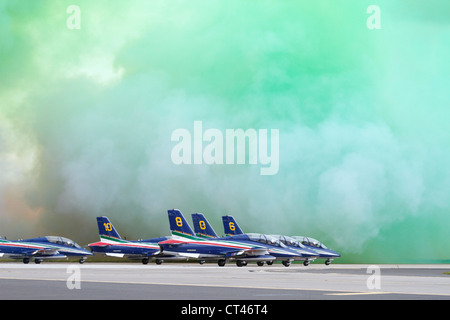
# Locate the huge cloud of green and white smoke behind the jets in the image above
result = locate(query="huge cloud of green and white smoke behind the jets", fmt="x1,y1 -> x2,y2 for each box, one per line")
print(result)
0,0 -> 450,262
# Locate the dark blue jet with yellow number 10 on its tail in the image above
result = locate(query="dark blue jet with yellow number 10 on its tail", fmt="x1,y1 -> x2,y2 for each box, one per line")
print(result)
88,216 -> 185,264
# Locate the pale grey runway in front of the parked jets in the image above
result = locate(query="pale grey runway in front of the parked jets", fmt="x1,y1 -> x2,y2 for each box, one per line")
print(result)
0,262 -> 450,301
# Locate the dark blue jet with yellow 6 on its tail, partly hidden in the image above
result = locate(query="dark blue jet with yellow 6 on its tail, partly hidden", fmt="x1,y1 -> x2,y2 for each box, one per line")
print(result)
222,215 -> 328,266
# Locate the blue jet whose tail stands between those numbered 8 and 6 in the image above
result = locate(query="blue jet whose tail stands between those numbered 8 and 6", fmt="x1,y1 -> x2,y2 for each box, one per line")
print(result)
192,213 -> 308,267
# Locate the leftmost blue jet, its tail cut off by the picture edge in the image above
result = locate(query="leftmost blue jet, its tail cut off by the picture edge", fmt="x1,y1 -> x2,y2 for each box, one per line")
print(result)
0,236 -> 92,264
